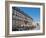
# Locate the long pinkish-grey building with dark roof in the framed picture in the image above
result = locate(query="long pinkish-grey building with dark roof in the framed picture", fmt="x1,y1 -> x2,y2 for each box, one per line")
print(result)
12,7 -> 33,31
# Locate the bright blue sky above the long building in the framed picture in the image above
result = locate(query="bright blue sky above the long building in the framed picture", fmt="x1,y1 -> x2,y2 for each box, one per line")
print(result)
20,7 -> 40,22
